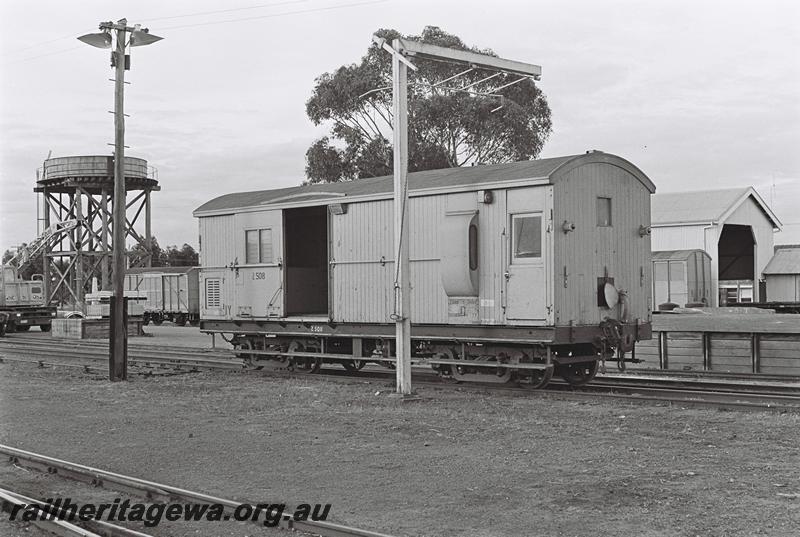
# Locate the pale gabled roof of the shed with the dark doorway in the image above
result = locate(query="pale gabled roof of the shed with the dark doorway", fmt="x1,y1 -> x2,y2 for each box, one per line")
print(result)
651,186 -> 781,229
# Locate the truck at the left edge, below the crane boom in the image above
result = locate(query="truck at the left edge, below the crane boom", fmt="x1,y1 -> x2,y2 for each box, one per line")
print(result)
0,265 -> 57,335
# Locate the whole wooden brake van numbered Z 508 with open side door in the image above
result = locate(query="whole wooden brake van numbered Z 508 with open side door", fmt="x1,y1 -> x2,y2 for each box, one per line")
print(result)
194,151 -> 655,387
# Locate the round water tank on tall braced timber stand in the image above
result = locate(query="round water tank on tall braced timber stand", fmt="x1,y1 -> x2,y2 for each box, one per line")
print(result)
34,156 -> 161,309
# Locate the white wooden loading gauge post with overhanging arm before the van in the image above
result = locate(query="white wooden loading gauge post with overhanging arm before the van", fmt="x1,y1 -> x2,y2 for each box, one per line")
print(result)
372,35 -> 542,395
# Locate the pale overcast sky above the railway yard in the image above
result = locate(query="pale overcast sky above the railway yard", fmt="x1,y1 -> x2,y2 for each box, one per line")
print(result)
0,0 -> 800,251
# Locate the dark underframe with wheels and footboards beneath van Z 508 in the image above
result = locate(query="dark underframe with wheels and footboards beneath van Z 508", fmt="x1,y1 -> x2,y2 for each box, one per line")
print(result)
200,319 -> 651,388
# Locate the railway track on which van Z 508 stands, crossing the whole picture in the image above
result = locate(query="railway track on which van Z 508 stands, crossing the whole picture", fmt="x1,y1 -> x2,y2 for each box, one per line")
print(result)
0,336 -> 800,411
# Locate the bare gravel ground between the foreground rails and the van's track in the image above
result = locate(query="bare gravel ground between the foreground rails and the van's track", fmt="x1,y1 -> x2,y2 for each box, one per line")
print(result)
0,352 -> 800,537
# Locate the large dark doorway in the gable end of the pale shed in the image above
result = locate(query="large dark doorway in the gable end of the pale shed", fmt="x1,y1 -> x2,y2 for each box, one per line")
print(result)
719,224 -> 756,305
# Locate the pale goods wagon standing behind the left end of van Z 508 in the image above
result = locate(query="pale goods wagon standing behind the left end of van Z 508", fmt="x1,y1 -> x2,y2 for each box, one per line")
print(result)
125,267 -> 200,326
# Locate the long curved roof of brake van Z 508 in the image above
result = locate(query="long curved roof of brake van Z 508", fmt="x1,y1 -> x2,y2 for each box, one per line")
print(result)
194,151 -> 655,216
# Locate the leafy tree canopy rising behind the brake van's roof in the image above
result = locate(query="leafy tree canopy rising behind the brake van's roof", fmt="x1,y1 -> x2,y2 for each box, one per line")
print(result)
306,26 -> 552,183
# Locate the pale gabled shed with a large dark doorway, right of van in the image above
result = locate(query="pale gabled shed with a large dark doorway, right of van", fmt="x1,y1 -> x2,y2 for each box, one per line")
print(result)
652,187 -> 781,306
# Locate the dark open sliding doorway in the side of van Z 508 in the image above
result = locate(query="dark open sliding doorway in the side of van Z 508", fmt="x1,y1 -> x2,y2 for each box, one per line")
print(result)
283,206 -> 328,316
